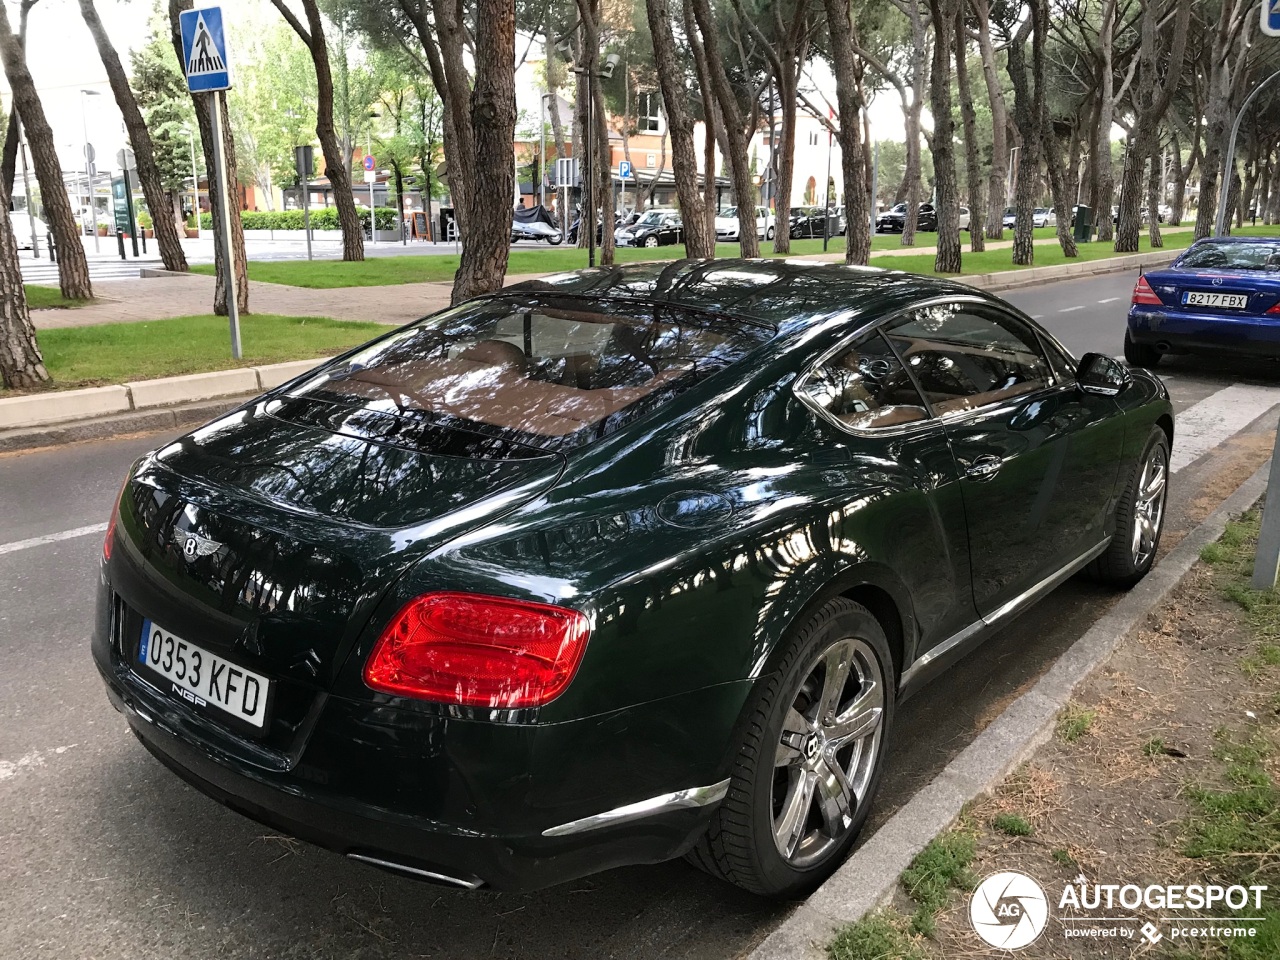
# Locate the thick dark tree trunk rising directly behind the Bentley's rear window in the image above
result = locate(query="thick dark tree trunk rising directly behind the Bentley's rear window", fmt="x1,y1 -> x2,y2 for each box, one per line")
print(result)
453,0 -> 516,303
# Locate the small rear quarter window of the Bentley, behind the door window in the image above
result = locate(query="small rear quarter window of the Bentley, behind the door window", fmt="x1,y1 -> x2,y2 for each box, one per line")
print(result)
797,333 -> 929,430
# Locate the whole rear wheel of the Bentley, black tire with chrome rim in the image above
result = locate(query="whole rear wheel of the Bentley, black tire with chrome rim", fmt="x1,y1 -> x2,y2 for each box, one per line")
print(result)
689,598 -> 896,897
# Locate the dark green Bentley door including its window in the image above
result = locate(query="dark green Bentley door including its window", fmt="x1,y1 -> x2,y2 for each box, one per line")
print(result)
887,297 -> 1124,617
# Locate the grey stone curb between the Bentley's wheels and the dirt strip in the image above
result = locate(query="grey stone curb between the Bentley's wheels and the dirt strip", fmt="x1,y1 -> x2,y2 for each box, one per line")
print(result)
746,461 -> 1270,960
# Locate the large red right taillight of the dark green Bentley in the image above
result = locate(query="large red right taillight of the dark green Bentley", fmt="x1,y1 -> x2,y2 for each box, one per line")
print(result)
365,593 -> 591,709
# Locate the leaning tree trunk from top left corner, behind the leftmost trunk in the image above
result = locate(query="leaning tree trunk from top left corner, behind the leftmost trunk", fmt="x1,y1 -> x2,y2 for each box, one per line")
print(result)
0,4 -> 93,300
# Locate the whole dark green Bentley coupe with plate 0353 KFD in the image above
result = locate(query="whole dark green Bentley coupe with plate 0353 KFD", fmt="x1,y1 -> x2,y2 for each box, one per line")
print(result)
93,260 -> 1174,896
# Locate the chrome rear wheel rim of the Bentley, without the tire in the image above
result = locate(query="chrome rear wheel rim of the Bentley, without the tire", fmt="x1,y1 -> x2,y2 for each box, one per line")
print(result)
771,637 -> 884,868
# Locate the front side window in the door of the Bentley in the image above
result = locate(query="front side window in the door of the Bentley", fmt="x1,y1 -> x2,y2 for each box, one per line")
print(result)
886,303 -> 1053,417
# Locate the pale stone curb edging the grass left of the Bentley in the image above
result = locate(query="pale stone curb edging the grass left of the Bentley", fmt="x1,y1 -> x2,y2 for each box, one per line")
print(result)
0,357 -> 332,435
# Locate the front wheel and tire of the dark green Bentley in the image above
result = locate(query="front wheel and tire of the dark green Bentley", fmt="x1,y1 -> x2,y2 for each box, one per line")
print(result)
1089,426 -> 1169,589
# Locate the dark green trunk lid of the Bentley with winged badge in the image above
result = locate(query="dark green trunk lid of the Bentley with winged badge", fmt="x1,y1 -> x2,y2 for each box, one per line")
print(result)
109,401 -> 562,753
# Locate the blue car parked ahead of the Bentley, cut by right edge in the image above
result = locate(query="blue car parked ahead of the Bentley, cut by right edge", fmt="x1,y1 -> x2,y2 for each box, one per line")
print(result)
1124,237 -> 1280,367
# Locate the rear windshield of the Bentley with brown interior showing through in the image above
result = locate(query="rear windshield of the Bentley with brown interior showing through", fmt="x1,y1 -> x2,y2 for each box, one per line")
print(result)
282,296 -> 773,458
